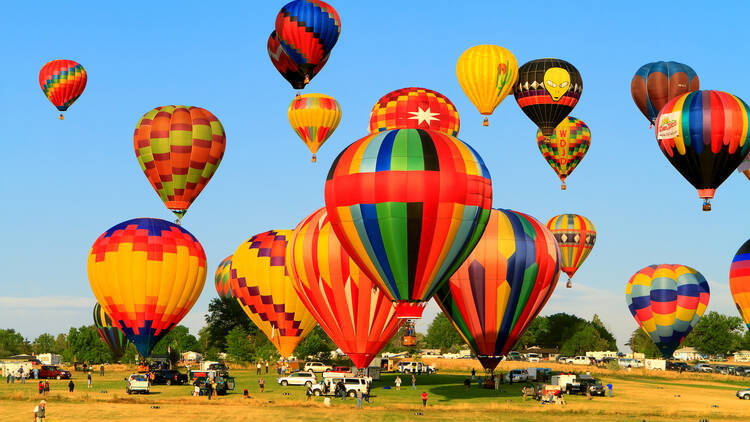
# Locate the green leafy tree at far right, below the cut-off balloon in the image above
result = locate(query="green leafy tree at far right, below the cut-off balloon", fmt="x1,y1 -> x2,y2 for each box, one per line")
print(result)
683,311 -> 744,356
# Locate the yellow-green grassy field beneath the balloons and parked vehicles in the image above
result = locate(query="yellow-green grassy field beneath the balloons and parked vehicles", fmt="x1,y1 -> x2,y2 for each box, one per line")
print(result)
0,362 -> 750,422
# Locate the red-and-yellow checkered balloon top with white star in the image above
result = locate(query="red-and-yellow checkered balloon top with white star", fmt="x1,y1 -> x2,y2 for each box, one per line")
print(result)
370,87 -> 461,136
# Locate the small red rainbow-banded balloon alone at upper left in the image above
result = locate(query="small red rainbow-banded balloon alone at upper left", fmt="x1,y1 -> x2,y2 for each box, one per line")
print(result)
39,60 -> 88,120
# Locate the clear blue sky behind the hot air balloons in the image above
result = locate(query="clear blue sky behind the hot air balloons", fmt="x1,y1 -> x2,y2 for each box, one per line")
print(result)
0,0 -> 750,346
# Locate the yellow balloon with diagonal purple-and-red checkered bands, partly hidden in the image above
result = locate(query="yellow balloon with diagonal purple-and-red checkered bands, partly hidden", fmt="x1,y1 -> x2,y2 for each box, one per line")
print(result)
230,230 -> 315,358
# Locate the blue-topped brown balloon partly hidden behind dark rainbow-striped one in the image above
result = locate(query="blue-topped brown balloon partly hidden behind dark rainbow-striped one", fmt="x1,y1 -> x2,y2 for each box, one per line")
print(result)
630,62 -> 700,125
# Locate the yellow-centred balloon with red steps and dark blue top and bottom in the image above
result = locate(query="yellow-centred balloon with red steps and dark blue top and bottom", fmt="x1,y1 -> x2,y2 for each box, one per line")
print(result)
88,218 -> 206,358
